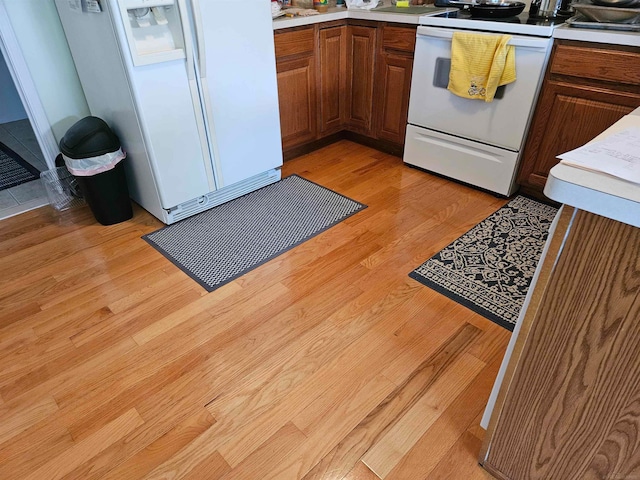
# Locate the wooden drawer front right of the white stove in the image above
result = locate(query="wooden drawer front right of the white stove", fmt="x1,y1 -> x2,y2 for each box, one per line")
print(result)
551,44 -> 640,85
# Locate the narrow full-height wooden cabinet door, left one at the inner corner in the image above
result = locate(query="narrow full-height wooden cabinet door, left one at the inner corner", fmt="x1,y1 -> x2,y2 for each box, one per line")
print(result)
318,25 -> 347,136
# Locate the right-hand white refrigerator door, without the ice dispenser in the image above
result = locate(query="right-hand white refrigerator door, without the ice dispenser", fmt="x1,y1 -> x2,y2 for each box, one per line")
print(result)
191,0 -> 282,188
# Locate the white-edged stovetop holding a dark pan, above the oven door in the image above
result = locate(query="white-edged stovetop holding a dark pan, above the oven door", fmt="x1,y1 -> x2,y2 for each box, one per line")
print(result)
420,10 -> 565,37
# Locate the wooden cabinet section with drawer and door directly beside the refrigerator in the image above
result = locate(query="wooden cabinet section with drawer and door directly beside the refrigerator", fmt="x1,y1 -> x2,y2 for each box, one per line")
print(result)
274,26 -> 317,151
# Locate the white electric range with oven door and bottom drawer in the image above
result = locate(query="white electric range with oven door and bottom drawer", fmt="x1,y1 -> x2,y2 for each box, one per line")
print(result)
403,11 -> 562,196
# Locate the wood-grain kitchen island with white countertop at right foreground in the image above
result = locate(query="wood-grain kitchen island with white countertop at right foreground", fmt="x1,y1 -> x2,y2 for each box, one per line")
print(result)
480,109 -> 640,480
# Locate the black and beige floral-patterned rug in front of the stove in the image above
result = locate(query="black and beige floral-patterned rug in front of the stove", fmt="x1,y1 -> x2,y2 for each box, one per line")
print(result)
409,196 -> 558,331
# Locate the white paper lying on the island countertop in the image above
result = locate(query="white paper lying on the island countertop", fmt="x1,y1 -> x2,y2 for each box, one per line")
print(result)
558,127 -> 640,184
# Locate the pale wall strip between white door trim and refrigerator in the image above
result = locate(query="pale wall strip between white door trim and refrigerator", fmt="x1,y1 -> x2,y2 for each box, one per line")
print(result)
0,0 -> 89,141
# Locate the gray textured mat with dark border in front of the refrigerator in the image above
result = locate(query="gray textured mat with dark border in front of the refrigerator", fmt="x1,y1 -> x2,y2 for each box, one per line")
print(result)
142,175 -> 367,292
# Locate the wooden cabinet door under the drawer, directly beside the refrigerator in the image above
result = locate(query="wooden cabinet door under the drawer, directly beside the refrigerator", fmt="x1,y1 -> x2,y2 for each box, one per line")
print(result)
276,56 -> 316,150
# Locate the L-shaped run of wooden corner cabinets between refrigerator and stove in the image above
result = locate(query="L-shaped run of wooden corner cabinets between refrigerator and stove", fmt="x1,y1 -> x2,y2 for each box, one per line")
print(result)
274,20 -> 416,159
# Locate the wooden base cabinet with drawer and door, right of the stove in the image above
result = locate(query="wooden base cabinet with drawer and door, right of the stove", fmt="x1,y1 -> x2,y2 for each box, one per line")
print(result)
518,40 -> 640,198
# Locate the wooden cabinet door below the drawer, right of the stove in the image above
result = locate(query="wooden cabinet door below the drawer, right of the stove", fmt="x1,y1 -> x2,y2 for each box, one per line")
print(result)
518,81 -> 640,194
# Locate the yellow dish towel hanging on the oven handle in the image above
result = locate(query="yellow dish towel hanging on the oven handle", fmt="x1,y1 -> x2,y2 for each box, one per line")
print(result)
448,32 -> 516,102
